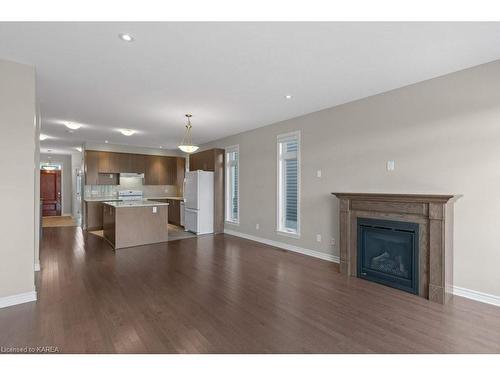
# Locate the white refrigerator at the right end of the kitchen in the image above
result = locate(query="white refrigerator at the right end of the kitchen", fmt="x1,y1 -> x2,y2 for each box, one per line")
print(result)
184,171 -> 214,234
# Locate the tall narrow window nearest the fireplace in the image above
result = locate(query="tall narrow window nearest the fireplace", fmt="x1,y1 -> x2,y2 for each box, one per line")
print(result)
277,132 -> 300,237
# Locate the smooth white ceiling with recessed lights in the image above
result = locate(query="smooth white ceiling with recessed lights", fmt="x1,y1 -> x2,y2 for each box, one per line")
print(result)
0,22 -> 500,152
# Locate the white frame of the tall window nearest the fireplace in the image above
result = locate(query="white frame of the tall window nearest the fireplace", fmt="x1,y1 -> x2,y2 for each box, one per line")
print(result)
276,130 -> 302,238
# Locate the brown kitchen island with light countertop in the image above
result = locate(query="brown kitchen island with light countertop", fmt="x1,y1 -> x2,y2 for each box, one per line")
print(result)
103,199 -> 168,250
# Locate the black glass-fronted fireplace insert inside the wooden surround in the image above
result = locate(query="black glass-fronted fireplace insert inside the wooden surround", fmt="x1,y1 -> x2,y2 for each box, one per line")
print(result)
357,218 -> 419,294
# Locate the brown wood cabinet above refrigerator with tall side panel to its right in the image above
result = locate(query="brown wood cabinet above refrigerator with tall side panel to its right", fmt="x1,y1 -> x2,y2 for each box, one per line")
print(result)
189,148 -> 224,233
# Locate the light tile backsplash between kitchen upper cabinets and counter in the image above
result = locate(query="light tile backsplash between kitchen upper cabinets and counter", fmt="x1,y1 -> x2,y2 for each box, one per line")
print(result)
85,177 -> 181,198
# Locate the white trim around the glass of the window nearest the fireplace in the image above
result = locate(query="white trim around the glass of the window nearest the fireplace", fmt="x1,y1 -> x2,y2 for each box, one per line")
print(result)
276,130 -> 302,238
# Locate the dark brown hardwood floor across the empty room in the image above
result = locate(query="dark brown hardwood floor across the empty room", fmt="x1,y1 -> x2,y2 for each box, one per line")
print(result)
0,227 -> 500,353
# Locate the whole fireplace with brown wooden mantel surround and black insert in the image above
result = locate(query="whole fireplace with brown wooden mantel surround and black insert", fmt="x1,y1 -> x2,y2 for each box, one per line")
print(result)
332,193 -> 460,303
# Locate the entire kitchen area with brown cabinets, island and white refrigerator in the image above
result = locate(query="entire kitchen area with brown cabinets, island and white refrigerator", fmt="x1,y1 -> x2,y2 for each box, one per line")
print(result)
83,149 -> 224,249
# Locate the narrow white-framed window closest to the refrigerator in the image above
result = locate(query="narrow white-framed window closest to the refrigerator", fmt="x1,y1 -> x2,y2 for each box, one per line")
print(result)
226,146 -> 240,224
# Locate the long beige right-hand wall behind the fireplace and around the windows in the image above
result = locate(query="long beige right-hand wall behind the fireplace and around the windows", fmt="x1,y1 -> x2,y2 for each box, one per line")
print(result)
203,61 -> 500,296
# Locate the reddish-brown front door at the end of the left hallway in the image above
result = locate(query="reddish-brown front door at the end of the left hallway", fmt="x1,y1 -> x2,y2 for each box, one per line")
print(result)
40,169 -> 62,216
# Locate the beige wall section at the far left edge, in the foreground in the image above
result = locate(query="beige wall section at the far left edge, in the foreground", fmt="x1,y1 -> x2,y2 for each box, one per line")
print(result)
0,60 -> 38,298
